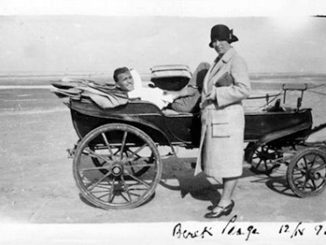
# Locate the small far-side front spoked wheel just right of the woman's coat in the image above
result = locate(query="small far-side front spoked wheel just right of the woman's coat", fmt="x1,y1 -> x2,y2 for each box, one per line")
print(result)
245,142 -> 283,174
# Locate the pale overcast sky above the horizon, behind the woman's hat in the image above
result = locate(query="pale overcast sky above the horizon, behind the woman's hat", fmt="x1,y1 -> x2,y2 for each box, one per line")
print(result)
0,0 -> 326,74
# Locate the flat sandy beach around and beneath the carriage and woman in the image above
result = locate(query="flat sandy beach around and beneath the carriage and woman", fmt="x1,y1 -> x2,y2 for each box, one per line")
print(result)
0,77 -> 326,223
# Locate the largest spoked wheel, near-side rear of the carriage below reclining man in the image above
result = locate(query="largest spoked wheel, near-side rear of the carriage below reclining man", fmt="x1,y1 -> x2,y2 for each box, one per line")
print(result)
73,123 -> 162,209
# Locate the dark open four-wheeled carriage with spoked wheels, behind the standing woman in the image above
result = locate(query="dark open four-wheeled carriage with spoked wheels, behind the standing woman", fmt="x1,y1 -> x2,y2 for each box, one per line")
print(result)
55,66 -> 326,209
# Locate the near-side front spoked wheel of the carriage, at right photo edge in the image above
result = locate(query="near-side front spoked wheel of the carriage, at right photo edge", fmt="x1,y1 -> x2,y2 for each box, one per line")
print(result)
286,148 -> 326,197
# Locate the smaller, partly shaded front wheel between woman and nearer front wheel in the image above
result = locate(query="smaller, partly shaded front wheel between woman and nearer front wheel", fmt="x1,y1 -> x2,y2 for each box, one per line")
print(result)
248,145 -> 282,173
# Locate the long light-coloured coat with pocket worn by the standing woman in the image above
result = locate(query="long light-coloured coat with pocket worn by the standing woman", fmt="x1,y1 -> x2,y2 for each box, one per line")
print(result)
195,48 -> 250,181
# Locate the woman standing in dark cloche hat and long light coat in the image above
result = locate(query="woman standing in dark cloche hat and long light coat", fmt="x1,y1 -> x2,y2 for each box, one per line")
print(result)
196,25 -> 250,218
